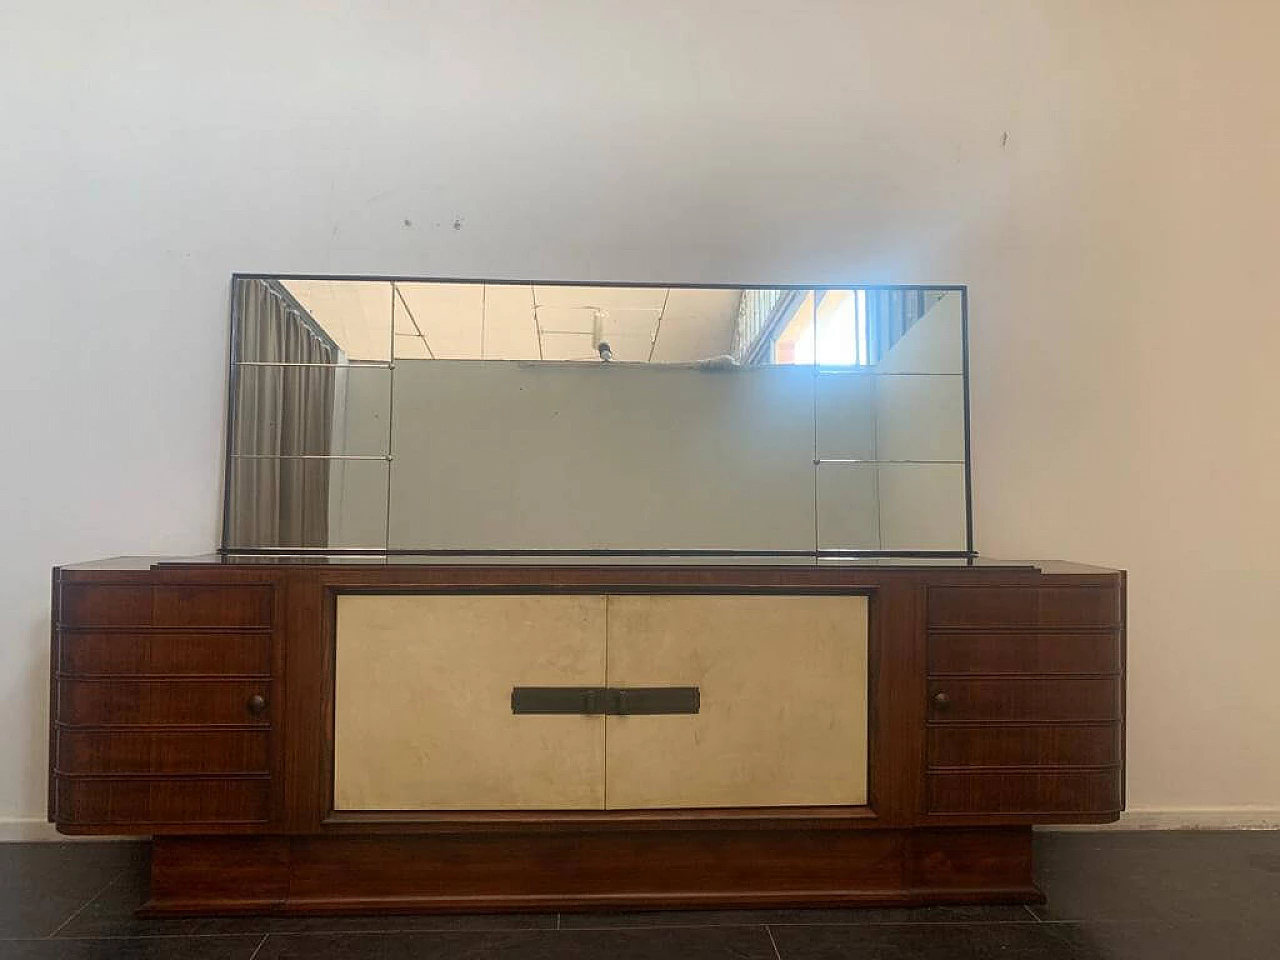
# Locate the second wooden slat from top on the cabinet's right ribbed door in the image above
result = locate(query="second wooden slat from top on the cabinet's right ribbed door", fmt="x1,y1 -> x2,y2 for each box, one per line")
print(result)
929,631 -> 1120,675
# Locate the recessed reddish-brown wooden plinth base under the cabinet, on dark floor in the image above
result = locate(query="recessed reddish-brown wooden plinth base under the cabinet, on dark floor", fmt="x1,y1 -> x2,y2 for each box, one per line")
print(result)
141,827 -> 1043,915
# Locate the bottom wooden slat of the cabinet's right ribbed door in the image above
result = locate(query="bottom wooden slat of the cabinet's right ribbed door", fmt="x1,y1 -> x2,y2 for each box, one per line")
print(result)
928,769 -> 1120,814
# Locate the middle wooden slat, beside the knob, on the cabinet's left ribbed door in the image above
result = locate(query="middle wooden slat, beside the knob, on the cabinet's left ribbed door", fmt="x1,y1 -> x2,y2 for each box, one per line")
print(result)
58,680 -> 270,726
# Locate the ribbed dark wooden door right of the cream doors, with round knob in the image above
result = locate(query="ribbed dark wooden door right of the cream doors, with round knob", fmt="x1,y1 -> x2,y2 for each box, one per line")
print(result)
924,586 -> 1124,820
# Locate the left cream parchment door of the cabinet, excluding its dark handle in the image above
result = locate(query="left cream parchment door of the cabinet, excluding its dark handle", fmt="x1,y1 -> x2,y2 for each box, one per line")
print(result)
334,594 -> 605,810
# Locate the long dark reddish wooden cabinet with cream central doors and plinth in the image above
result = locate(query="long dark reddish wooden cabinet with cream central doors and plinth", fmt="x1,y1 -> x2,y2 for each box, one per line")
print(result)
49,557 -> 1124,913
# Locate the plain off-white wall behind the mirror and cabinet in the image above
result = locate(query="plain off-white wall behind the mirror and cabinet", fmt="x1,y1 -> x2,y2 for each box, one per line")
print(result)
0,0 -> 1280,818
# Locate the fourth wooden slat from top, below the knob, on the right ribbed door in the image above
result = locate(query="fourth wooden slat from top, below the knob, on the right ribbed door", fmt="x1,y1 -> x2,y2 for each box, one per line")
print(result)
928,723 -> 1120,767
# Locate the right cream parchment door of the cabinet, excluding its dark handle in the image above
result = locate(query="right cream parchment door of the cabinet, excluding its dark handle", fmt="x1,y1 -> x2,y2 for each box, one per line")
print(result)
605,595 -> 868,809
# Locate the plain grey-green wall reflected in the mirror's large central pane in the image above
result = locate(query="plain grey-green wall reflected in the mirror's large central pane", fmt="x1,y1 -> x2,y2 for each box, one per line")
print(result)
390,361 -> 813,550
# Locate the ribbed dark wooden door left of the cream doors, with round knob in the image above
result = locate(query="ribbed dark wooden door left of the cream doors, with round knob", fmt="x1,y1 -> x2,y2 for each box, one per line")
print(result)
50,581 -> 274,832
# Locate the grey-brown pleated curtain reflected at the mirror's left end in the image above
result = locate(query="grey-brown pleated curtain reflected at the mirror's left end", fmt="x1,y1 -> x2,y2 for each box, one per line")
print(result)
227,280 -> 339,548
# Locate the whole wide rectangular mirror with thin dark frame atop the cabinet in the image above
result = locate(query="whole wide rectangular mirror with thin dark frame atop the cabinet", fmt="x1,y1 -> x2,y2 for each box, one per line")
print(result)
223,275 -> 973,556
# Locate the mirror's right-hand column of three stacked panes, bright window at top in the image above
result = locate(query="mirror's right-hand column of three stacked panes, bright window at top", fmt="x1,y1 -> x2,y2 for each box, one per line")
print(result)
815,289 -> 968,553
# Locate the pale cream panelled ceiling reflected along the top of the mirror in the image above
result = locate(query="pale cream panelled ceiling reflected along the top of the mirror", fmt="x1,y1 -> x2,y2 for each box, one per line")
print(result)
284,280 -> 741,362
